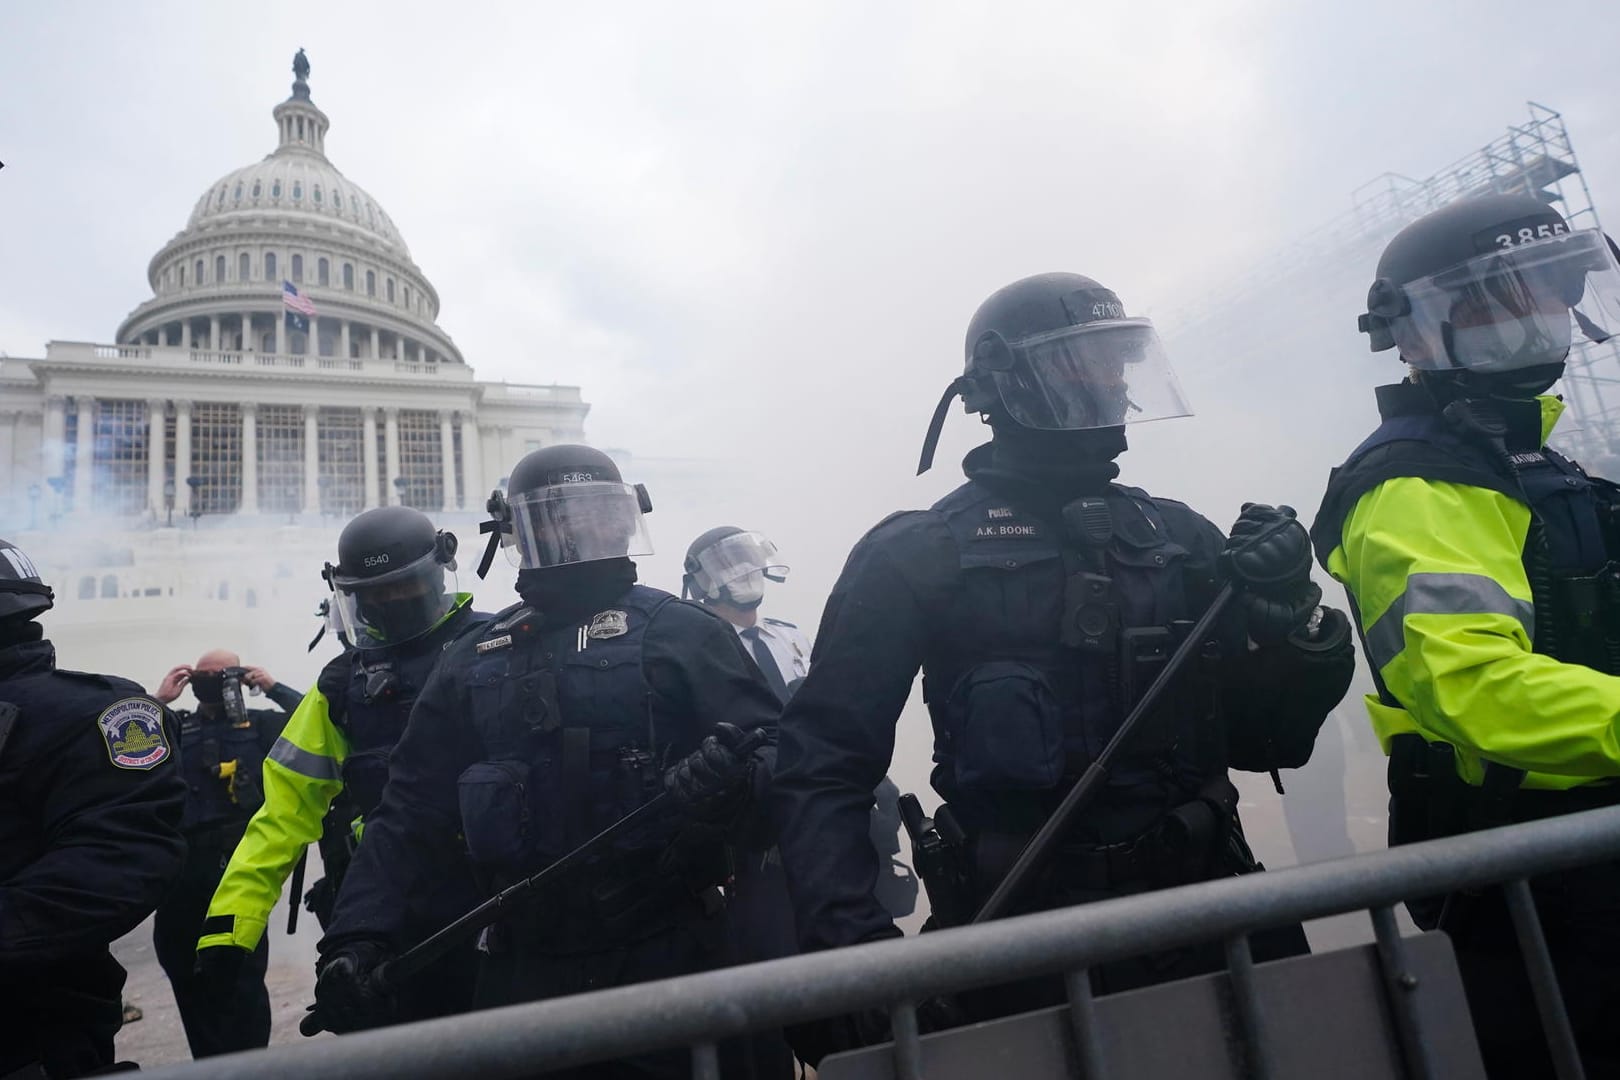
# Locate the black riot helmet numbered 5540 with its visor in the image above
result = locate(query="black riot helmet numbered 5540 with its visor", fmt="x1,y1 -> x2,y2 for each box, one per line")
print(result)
322,507 -> 455,649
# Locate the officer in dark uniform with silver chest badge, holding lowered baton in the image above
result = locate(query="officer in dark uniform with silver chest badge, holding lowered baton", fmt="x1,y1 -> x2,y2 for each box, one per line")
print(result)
316,445 -> 779,1077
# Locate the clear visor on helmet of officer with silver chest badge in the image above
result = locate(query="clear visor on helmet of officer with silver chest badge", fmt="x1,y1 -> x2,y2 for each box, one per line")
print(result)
507,481 -> 653,570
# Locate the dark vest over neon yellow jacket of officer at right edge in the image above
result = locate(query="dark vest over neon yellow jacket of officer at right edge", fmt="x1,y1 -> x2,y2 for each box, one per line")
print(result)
1311,384 -> 1620,680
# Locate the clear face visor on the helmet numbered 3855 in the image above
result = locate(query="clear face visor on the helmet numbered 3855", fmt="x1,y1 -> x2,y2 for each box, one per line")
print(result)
1390,230 -> 1620,371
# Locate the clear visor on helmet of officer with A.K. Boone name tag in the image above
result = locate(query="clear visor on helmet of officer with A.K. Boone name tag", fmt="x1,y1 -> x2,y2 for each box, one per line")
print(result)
993,319 -> 1192,431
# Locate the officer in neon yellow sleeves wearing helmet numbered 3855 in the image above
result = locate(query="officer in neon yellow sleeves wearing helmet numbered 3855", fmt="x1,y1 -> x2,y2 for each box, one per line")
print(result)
1312,194 -> 1620,1077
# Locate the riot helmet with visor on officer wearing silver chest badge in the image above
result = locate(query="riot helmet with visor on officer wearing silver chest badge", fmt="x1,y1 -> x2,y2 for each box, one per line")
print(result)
478,444 -> 653,578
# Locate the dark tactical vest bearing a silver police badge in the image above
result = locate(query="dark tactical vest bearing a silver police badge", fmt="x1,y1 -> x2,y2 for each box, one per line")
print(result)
458,585 -> 674,868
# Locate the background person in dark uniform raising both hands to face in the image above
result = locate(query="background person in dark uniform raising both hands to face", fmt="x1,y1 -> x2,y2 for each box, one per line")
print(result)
152,649 -> 300,1057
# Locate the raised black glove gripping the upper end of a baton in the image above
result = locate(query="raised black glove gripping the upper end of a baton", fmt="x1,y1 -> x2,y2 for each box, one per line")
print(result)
1220,502 -> 1322,644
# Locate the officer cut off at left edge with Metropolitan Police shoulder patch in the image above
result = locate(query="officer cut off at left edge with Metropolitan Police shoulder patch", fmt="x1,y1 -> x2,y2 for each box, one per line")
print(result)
0,541 -> 186,1080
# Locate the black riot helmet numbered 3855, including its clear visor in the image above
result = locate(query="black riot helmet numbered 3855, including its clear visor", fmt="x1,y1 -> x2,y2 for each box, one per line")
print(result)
1358,194 -> 1620,395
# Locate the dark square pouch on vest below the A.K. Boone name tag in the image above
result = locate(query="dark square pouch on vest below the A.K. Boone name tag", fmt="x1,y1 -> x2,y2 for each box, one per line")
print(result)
944,661 -> 1064,790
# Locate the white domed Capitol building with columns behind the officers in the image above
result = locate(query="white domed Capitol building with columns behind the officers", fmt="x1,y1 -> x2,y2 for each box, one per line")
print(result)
0,50 -> 590,534
